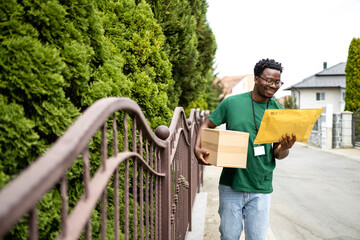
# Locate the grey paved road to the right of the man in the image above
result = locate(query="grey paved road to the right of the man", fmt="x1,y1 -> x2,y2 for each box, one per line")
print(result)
270,145 -> 360,240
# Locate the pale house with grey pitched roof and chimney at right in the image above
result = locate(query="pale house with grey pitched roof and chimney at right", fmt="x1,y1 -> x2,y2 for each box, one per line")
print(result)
285,62 -> 346,113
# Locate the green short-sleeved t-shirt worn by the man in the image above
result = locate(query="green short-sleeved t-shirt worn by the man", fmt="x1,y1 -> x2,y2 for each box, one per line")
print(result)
209,92 -> 283,193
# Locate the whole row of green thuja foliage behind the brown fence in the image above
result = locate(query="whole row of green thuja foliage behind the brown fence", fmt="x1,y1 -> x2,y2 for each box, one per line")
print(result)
0,0 -> 216,239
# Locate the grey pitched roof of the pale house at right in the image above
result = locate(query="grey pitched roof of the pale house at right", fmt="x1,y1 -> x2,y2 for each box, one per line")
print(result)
285,62 -> 346,90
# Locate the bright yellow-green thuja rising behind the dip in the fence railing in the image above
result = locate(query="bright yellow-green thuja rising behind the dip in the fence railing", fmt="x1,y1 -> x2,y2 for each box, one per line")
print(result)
99,0 -> 173,127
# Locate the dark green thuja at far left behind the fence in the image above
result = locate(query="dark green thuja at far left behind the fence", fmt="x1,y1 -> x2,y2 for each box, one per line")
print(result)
0,1 -> 82,239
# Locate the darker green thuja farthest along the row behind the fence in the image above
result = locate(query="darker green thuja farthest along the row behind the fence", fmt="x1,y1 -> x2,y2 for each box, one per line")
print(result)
148,0 -> 216,108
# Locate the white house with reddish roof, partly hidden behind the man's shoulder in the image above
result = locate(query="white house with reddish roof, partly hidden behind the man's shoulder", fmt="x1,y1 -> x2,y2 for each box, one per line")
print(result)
215,74 -> 254,99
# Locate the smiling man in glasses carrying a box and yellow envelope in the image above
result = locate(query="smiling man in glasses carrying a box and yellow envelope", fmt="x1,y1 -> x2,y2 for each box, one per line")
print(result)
194,59 -> 296,240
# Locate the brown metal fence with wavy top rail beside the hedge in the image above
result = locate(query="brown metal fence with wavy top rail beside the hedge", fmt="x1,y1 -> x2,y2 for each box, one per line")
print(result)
0,98 -> 207,240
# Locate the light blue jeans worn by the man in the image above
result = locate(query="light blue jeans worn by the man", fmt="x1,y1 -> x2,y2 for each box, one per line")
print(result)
219,185 -> 271,240
